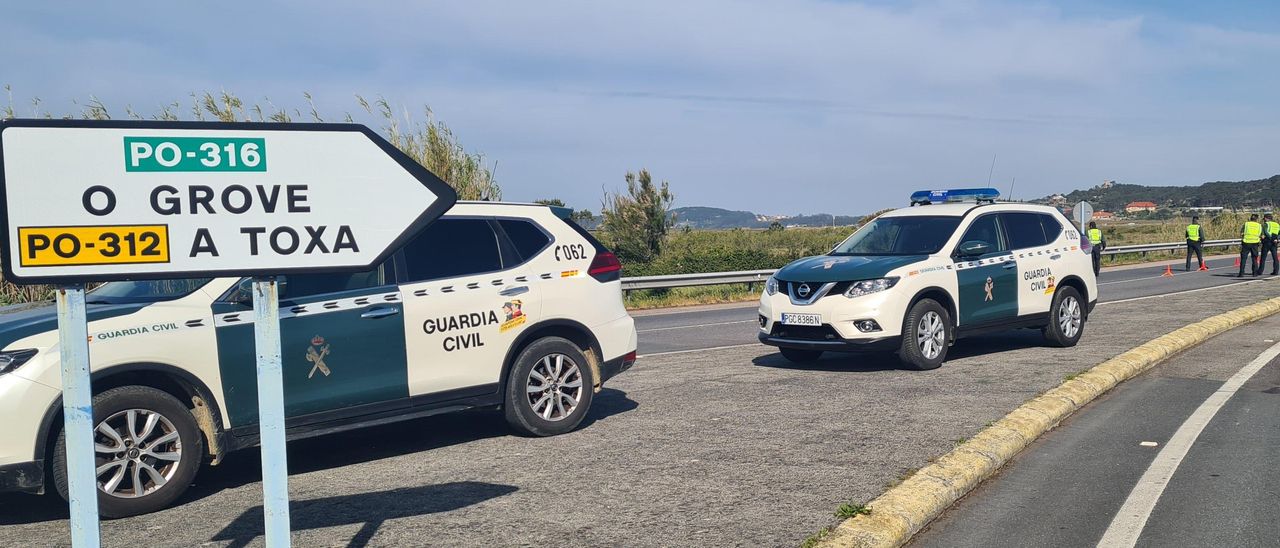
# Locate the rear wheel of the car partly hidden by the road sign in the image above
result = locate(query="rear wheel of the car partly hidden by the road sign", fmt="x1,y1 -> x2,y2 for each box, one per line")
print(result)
503,337 -> 595,437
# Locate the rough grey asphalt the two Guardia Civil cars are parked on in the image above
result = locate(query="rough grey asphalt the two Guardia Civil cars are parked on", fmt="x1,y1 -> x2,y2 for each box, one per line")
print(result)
0,258 -> 1280,547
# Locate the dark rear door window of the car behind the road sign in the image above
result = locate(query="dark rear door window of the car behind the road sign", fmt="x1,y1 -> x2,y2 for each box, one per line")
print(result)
404,219 -> 502,282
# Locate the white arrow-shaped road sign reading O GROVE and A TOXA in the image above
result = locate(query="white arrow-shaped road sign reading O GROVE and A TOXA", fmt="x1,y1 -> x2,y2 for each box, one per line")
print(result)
0,120 -> 457,283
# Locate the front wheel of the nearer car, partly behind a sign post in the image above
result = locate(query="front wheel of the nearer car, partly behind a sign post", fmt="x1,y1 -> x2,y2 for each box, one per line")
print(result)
52,385 -> 205,517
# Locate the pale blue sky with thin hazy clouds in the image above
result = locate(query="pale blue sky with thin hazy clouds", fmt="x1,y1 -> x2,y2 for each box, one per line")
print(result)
0,0 -> 1280,214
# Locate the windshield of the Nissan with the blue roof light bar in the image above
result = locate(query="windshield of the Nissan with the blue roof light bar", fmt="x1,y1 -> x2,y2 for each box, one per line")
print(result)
831,215 -> 960,255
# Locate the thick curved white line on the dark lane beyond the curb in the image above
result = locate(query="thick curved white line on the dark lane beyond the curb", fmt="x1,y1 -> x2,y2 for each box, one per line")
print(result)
1098,343 -> 1280,548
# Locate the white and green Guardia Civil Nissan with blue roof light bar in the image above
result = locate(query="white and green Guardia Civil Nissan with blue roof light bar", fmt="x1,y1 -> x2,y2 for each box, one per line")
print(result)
759,188 -> 1098,370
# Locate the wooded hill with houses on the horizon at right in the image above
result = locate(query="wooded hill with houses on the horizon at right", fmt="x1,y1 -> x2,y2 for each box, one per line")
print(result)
1036,175 -> 1280,211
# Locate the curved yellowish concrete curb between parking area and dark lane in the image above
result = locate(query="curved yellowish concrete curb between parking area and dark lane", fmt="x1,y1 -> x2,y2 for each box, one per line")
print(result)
817,297 -> 1280,548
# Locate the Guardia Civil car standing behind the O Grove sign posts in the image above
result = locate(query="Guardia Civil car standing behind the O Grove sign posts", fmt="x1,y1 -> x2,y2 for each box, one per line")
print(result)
0,202 -> 636,517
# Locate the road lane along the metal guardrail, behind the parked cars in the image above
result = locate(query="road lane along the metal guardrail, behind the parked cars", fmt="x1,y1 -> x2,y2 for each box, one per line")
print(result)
635,257 -> 1274,356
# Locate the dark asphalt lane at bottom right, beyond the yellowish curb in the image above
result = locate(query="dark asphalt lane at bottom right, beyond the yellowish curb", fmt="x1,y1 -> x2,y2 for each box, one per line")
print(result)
913,316 -> 1280,548
